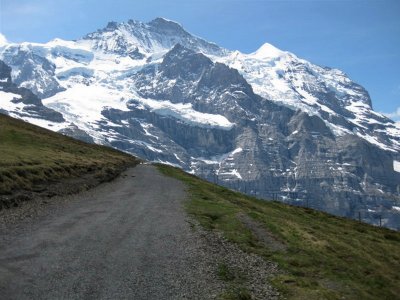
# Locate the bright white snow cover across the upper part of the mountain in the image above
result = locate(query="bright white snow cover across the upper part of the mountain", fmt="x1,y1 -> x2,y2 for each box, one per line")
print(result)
0,19 -> 400,151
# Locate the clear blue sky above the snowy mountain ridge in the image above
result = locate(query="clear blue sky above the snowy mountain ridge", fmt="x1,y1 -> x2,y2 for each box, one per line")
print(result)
0,0 -> 400,120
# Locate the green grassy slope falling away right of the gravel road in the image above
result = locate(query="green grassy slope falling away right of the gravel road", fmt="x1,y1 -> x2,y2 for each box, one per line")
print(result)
159,165 -> 400,299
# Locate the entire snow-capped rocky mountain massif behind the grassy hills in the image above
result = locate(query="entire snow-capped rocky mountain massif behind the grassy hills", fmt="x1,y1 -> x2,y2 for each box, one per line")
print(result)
0,18 -> 400,228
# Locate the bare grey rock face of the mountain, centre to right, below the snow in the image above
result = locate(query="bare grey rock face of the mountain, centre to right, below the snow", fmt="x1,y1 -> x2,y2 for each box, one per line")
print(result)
132,46 -> 400,227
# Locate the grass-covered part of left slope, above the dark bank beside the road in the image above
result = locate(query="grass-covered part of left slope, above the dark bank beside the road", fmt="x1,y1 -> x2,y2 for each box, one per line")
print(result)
0,114 -> 136,194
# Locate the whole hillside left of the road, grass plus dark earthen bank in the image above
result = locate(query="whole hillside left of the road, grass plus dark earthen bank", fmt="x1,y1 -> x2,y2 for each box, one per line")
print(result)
0,114 -> 138,209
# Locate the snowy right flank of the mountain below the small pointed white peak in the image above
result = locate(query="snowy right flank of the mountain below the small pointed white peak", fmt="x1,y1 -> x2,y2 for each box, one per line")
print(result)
215,44 -> 400,152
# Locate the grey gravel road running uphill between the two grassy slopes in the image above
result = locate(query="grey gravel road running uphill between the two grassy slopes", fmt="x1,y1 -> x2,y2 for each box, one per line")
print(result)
0,165 -> 276,299
